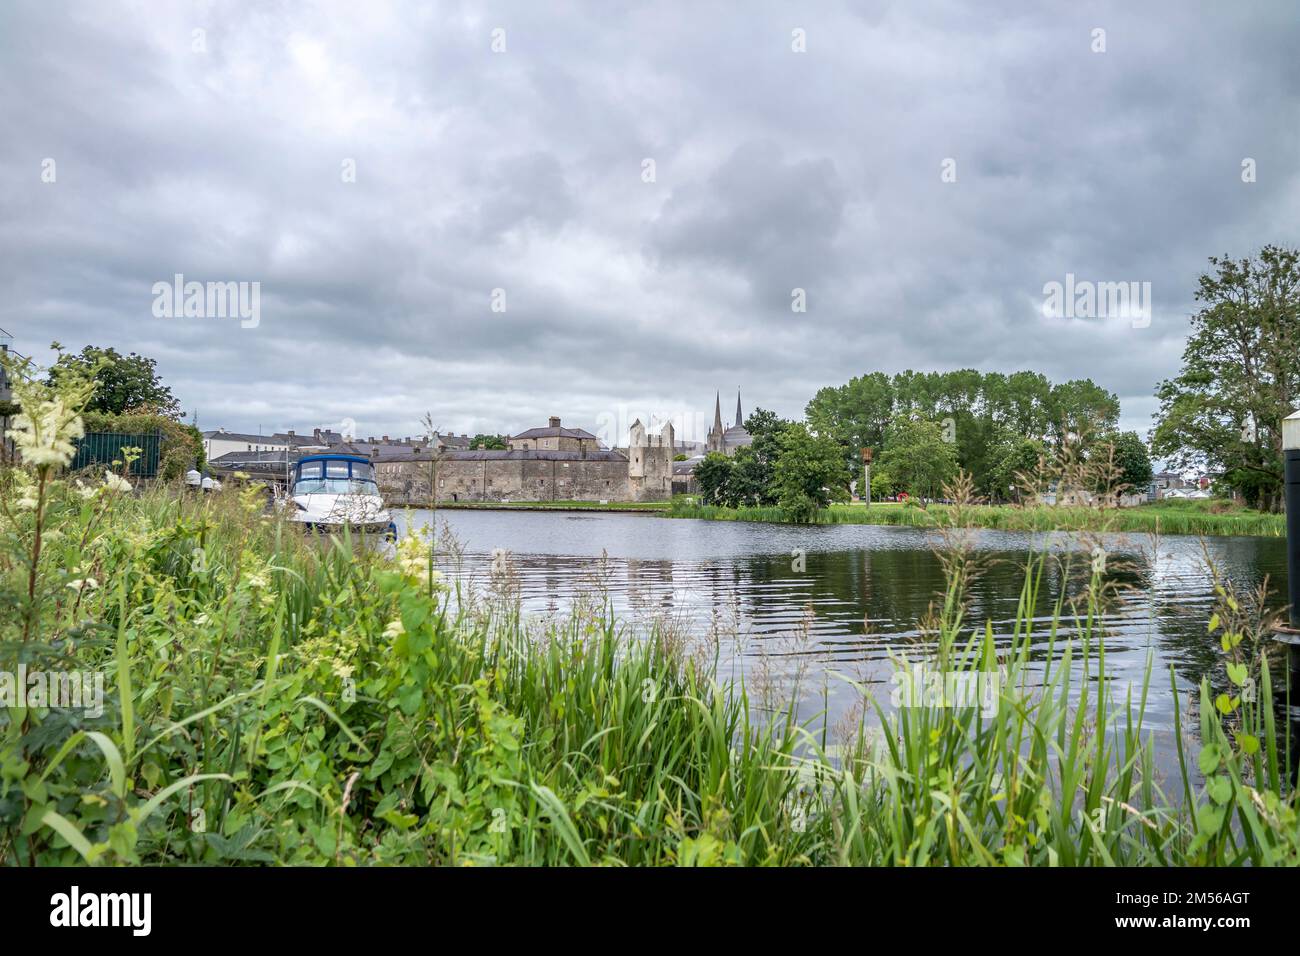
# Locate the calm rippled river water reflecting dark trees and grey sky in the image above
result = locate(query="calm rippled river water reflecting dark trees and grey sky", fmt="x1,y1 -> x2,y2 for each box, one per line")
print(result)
398,510 -> 1286,764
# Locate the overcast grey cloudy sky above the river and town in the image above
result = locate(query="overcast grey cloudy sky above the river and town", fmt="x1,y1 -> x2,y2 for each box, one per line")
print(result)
0,0 -> 1300,441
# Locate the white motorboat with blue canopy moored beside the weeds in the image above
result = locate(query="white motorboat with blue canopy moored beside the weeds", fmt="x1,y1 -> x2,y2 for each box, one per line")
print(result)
289,454 -> 397,537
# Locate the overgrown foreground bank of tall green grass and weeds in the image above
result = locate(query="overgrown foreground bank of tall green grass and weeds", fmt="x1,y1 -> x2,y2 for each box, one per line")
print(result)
0,477 -> 1300,865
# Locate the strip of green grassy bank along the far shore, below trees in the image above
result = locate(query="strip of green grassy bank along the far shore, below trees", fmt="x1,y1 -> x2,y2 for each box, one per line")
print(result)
667,501 -> 1287,537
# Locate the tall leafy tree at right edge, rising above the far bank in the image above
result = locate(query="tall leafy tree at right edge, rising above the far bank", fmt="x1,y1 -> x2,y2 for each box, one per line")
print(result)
1151,246 -> 1300,511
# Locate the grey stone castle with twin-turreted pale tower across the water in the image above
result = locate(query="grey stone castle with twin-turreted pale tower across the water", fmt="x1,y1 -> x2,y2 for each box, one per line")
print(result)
371,418 -> 676,505
